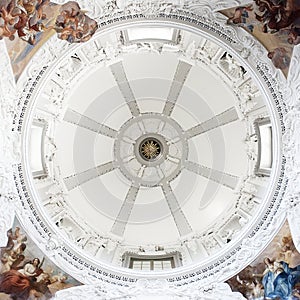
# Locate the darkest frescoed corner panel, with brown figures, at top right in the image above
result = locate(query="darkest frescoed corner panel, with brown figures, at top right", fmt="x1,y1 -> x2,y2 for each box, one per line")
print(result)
220,0 -> 300,76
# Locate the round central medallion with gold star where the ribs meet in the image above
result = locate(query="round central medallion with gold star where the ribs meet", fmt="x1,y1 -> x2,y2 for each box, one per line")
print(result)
114,113 -> 188,187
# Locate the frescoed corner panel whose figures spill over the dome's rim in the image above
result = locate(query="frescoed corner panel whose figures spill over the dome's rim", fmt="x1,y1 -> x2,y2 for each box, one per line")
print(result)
0,0 -> 98,80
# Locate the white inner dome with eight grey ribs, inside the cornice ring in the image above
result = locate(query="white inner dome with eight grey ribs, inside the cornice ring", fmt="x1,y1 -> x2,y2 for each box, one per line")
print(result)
28,25 -> 272,263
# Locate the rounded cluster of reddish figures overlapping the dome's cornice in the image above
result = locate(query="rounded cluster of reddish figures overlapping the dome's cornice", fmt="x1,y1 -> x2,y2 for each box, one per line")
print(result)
55,1 -> 98,43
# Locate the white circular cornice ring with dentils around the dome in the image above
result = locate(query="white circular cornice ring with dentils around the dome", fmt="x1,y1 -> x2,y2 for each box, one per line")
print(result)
15,10 -> 287,285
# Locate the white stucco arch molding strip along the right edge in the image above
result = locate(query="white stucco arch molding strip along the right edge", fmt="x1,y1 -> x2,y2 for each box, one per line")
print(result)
283,45 -> 300,251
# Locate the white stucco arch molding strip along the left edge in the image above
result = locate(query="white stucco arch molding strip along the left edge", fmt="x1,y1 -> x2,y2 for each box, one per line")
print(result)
0,41 -> 21,247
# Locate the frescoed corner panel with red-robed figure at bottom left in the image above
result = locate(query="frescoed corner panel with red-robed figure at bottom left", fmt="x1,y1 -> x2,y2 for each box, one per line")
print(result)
0,219 -> 81,300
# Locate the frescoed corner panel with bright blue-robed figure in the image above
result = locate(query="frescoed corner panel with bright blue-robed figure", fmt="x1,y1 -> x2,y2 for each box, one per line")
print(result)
227,222 -> 300,300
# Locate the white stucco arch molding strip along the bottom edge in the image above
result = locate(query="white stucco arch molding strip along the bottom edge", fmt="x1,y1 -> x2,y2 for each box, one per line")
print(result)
54,279 -> 245,300
